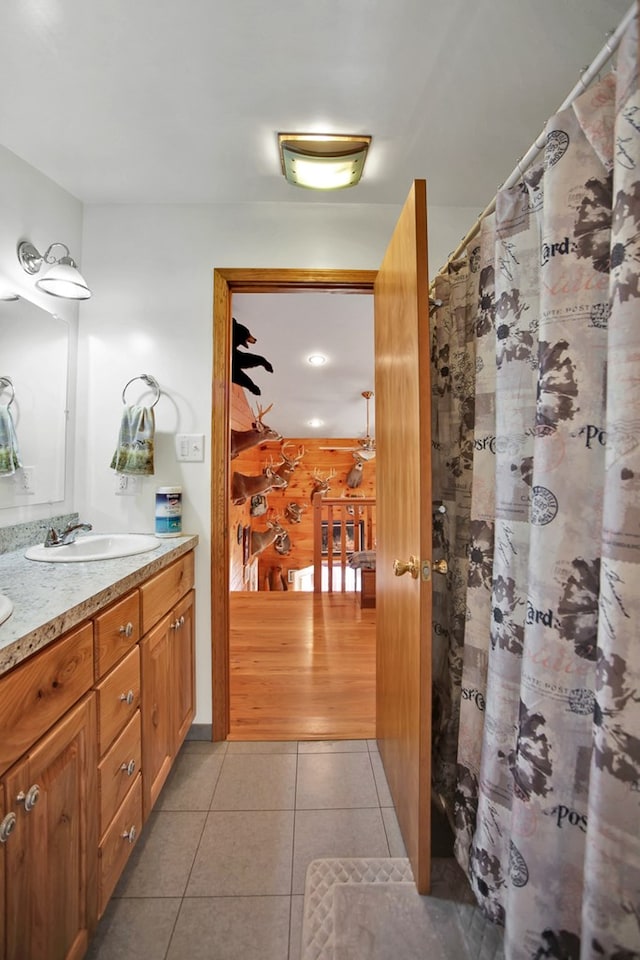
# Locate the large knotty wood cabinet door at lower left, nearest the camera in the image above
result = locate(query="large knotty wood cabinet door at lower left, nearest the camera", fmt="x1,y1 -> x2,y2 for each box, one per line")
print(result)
4,694 -> 98,960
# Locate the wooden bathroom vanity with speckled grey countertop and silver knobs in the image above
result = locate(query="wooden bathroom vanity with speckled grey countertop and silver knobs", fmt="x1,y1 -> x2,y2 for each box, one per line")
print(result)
0,537 -> 198,960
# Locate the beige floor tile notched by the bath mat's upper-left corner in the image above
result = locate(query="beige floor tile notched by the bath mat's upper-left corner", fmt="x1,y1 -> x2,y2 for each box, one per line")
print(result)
292,809 -> 389,894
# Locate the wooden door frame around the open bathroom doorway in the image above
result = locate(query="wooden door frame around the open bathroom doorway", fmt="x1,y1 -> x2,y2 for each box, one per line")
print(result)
211,267 -> 377,740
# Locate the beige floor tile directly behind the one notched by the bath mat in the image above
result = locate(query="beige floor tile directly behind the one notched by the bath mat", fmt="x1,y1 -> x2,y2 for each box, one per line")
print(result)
296,752 -> 379,810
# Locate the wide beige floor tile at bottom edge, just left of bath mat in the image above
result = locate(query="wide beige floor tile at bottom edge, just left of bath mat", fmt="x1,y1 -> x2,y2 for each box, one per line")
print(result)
167,897 -> 290,960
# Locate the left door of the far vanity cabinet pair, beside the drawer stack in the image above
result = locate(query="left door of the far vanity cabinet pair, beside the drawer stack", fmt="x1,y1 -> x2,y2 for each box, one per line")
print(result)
140,614 -> 175,821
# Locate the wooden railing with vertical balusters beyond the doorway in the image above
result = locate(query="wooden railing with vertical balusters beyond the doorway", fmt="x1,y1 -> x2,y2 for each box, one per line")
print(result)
312,493 -> 376,593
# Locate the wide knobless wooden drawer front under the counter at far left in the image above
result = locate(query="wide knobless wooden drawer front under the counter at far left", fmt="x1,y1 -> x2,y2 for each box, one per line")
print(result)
0,623 -> 93,773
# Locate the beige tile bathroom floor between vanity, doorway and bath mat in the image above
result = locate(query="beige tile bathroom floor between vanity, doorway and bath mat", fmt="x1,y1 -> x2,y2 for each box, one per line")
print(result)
87,740 -> 464,960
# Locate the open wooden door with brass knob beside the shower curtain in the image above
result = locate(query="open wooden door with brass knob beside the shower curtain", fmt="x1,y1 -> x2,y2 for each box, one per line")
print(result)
374,180 -> 431,893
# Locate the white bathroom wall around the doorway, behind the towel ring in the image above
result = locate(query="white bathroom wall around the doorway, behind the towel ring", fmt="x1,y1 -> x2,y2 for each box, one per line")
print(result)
76,199 -> 477,723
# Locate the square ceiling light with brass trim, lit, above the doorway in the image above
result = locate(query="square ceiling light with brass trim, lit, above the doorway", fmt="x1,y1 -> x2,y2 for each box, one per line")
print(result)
278,133 -> 371,190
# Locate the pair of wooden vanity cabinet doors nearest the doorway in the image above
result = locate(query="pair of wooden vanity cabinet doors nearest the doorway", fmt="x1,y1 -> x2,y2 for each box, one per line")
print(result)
140,590 -> 195,820
